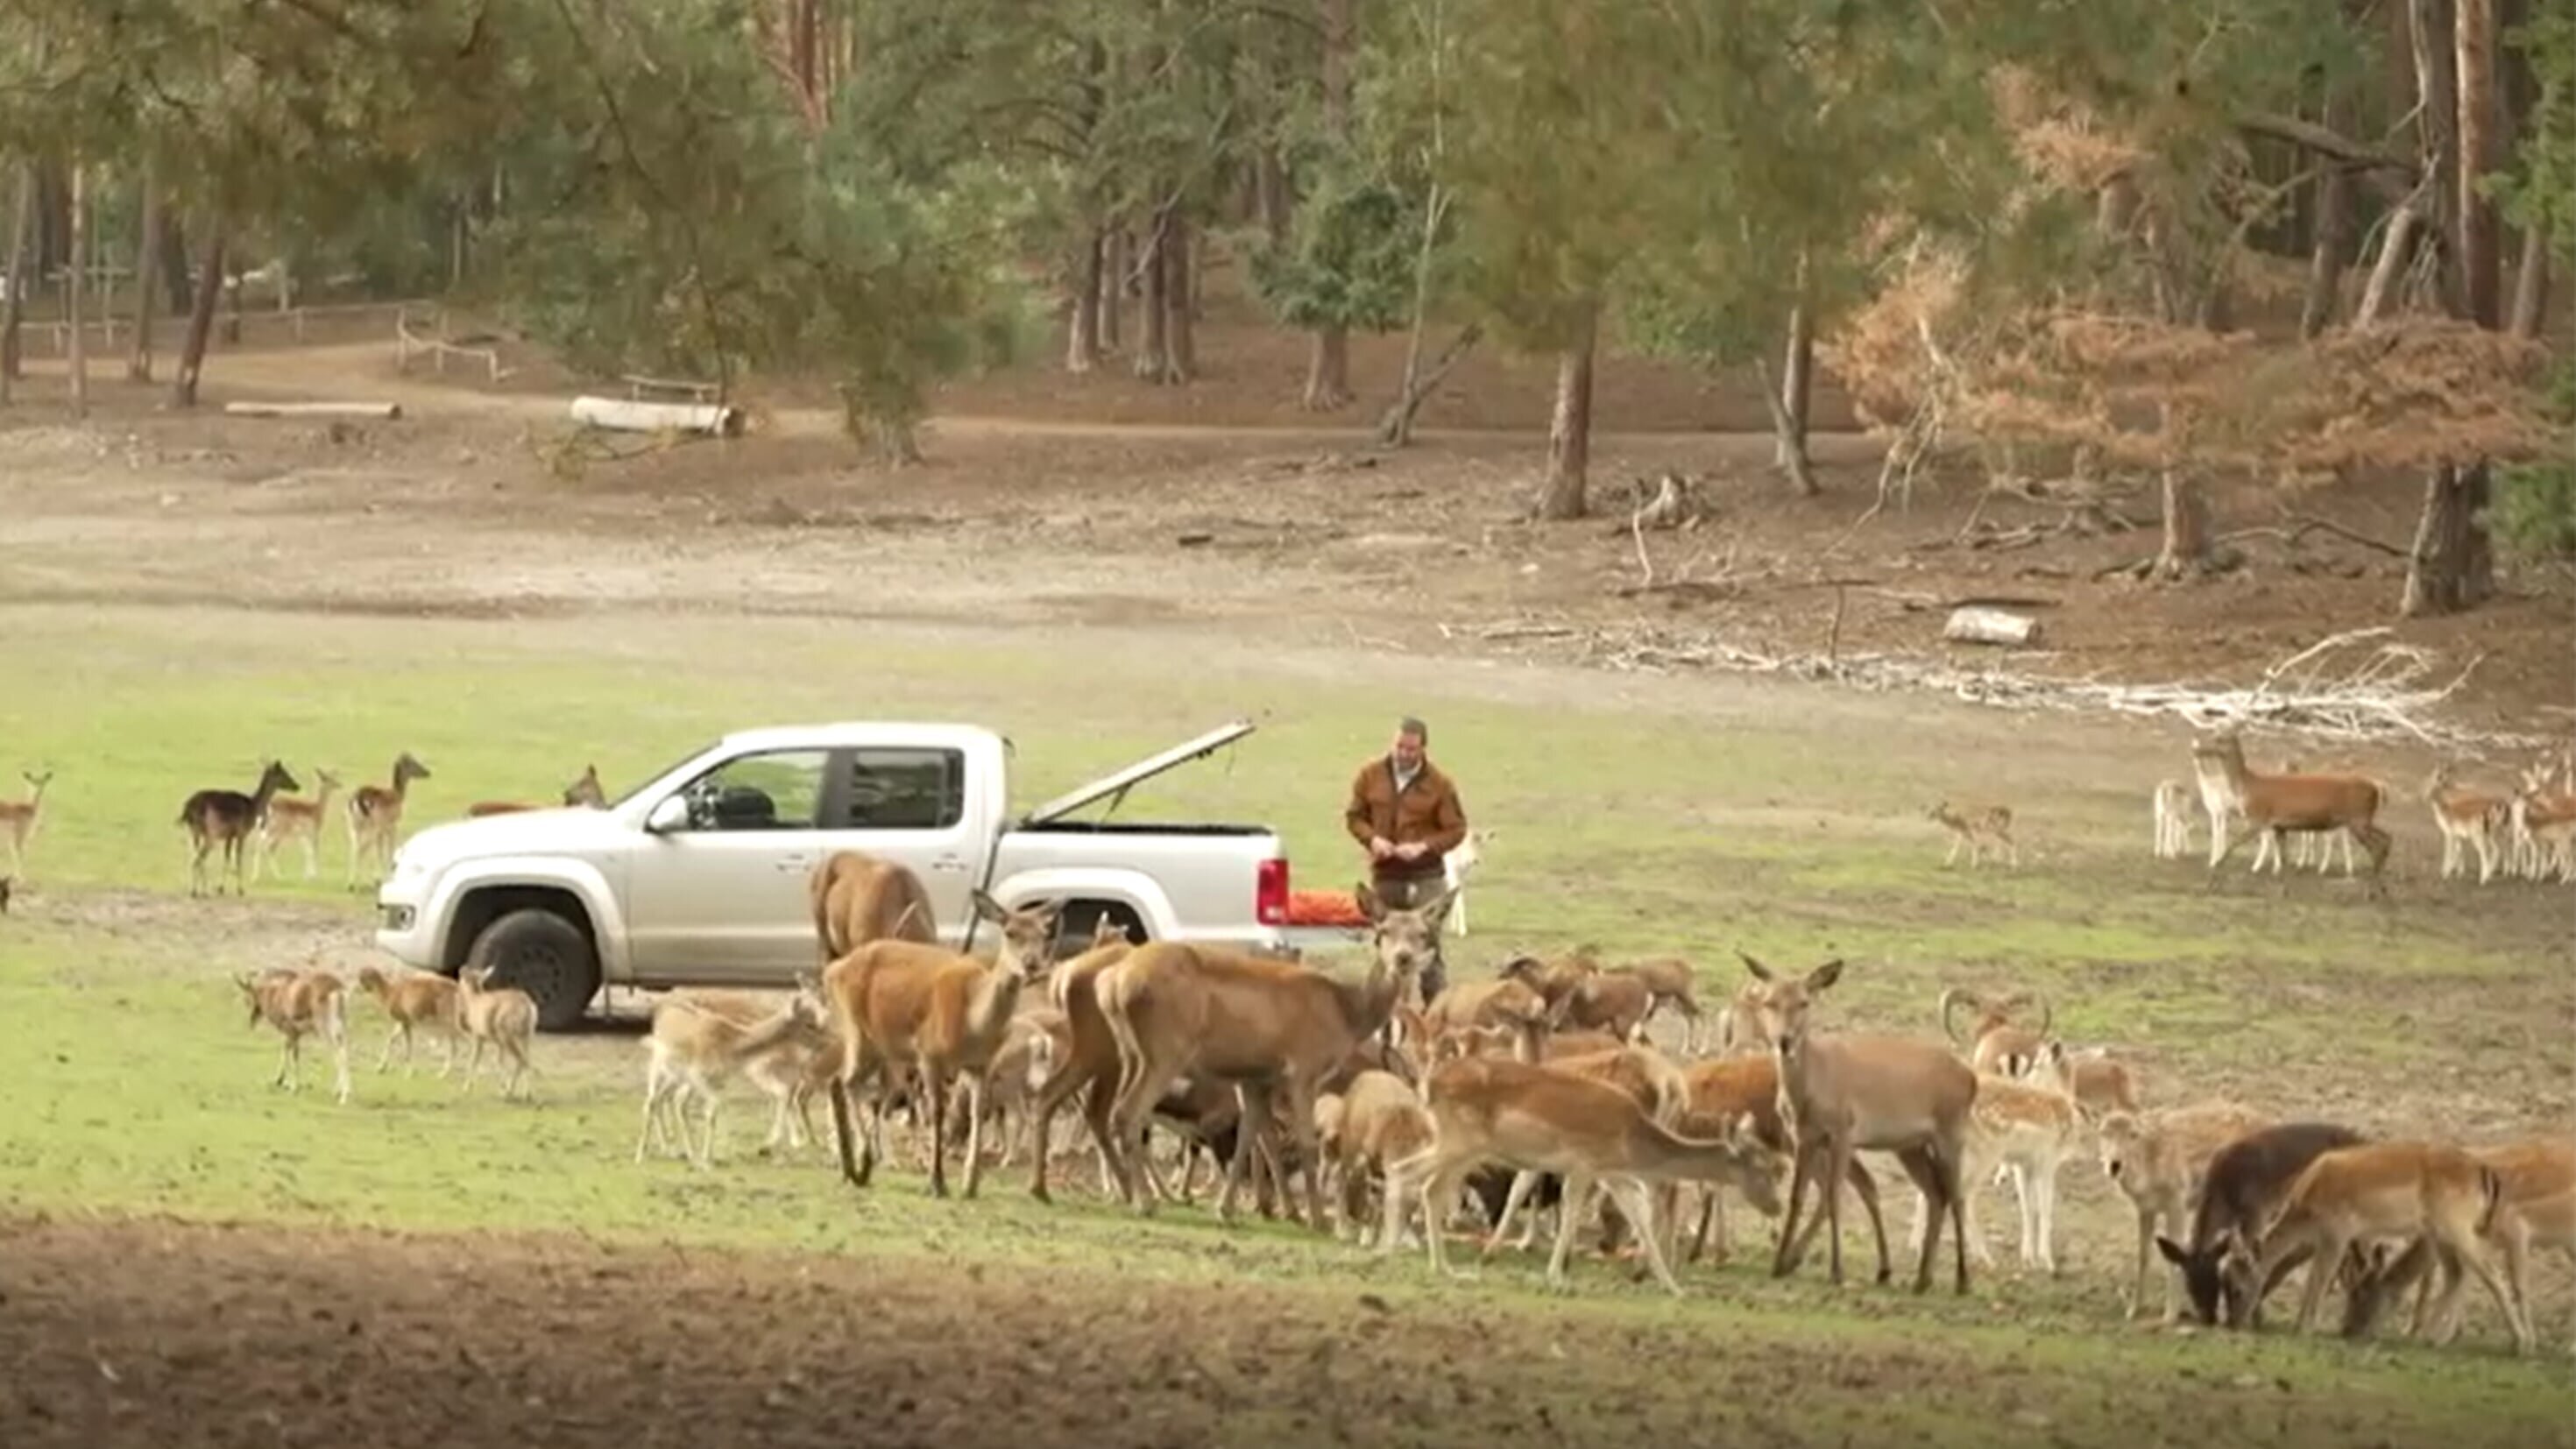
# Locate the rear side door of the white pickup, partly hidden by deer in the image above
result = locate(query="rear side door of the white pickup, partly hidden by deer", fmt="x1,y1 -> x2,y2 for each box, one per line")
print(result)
809,744 -> 989,952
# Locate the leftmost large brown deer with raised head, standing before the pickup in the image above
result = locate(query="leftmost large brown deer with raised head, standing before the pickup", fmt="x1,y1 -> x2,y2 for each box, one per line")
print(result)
822,890 -> 1064,1197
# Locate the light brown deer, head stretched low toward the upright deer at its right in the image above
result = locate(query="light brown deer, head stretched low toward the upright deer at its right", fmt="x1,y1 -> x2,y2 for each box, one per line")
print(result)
1378,1057 -> 1773,1297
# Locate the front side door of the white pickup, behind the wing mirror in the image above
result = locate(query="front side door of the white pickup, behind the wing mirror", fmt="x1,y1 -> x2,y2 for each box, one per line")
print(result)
626,749 -> 838,980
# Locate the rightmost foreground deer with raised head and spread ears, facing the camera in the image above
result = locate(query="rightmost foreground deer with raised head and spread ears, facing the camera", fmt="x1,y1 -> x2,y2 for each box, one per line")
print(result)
1737,950 -> 1978,1292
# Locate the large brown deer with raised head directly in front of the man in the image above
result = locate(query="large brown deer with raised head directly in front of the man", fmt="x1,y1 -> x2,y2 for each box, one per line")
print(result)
1093,883 -> 1450,1230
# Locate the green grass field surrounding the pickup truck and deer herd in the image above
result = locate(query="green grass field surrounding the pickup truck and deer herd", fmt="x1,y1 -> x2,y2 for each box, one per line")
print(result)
0,610 -> 2568,1444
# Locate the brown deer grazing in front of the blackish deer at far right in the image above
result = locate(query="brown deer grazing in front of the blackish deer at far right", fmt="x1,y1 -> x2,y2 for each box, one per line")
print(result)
2241,1142 -> 2532,1354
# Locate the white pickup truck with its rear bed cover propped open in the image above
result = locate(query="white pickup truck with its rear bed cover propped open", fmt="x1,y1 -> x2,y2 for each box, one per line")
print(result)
376,721 -> 1337,1029
